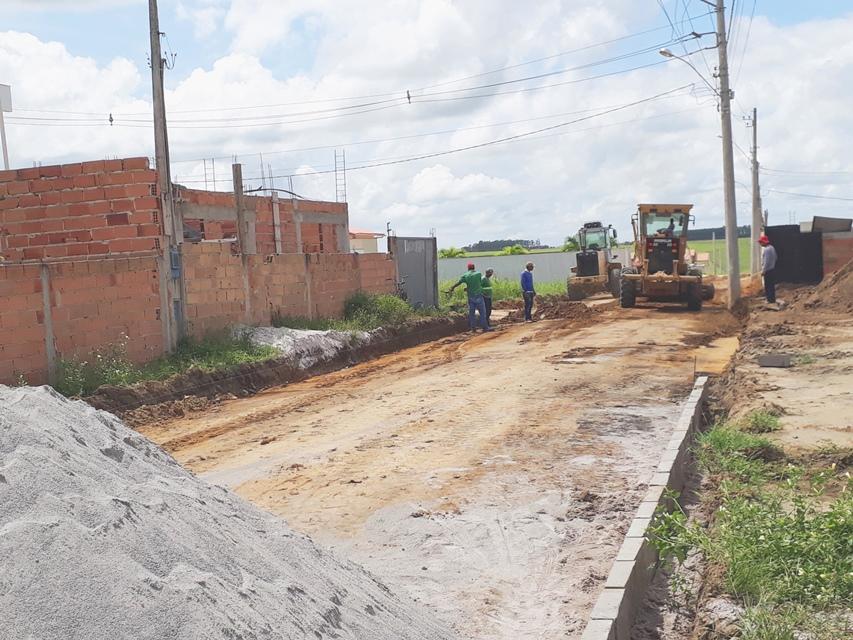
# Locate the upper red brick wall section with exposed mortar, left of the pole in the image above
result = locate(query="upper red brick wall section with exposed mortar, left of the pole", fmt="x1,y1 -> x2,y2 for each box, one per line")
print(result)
0,158 -> 161,260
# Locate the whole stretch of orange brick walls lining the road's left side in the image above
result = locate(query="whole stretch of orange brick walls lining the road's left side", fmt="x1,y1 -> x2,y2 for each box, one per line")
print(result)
0,158 -> 396,383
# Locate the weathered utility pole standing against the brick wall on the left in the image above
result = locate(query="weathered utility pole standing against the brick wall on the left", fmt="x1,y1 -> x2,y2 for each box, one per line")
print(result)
148,0 -> 185,351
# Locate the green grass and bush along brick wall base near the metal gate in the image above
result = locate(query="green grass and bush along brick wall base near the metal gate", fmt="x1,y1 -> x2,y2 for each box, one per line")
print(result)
272,292 -> 444,331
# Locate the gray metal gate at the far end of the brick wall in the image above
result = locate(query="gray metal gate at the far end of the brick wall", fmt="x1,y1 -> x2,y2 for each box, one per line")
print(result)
388,236 -> 438,308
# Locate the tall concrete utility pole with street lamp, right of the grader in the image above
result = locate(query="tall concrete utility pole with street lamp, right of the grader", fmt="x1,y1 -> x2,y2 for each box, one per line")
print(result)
709,0 -> 740,308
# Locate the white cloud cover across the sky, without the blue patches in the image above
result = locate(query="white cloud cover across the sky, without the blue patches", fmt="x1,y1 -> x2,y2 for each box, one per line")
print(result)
0,5 -> 853,250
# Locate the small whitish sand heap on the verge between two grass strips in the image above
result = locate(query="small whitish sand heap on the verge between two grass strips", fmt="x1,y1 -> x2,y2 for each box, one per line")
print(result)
238,327 -> 371,369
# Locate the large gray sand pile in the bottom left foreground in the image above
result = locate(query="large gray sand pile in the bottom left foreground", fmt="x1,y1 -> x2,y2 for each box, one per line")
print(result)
0,386 -> 460,640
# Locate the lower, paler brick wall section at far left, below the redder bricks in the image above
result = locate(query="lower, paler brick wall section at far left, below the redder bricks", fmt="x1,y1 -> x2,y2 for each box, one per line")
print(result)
0,256 -> 163,384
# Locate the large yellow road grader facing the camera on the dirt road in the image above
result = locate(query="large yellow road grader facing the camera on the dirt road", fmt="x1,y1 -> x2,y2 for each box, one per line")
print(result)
619,204 -> 714,311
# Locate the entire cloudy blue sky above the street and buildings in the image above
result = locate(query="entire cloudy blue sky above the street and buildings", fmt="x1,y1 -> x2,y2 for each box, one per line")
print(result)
0,0 -> 853,247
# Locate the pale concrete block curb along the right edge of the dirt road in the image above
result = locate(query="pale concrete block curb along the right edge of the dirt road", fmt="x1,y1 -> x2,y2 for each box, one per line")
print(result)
581,376 -> 708,640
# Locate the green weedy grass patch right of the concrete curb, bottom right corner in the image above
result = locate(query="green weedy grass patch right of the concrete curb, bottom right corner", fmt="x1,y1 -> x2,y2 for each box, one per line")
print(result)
649,412 -> 853,640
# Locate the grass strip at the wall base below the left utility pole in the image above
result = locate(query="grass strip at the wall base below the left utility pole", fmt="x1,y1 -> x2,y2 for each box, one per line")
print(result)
54,331 -> 278,397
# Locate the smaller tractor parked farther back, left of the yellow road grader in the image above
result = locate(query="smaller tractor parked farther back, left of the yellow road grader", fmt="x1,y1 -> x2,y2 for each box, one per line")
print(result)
566,222 -> 622,300
